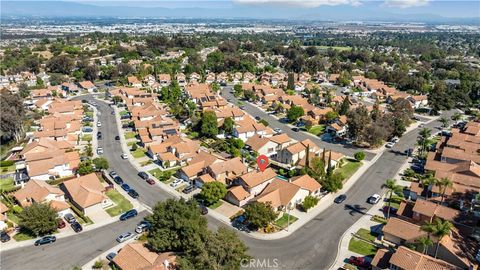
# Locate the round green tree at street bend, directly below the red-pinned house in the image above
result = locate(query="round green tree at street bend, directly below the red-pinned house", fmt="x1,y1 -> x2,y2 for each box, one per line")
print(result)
243,202 -> 277,229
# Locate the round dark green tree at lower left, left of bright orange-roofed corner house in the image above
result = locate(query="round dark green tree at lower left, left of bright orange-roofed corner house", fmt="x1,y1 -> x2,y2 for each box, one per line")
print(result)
18,203 -> 58,236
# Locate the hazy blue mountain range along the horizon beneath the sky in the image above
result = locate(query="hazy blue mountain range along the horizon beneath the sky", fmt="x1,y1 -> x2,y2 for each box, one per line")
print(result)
0,1 -> 480,24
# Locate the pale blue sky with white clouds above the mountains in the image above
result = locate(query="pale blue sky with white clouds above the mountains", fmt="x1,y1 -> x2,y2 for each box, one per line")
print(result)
2,0 -> 480,20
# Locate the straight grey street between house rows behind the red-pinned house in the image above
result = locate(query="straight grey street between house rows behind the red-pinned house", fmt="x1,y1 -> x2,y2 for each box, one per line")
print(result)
221,86 -> 375,160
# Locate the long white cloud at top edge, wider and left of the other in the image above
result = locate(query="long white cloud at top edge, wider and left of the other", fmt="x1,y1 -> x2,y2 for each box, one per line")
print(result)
234,0 -> 361,8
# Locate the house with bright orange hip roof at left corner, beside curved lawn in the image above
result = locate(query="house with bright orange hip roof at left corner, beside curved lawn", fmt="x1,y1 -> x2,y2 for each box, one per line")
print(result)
61,173 -> 112,216
